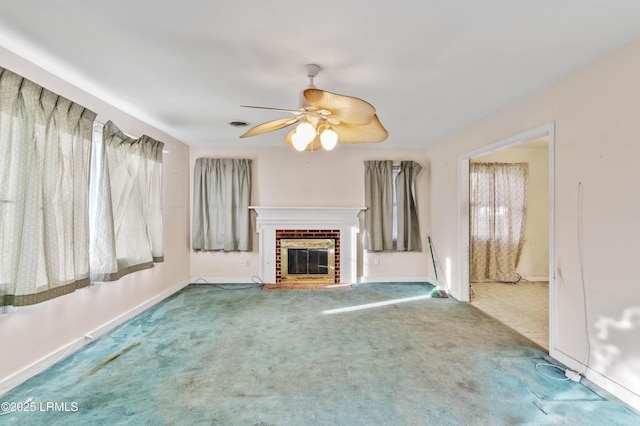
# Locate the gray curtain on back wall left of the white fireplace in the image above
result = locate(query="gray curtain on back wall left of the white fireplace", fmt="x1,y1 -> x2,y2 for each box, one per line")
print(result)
192,158 -> 252,251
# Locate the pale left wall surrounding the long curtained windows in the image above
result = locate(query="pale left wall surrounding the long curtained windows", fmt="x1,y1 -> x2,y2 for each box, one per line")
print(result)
0,48 -> 189,394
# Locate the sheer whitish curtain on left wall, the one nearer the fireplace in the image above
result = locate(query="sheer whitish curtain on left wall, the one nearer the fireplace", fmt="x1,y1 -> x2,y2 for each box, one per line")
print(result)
91,121 -> 164,281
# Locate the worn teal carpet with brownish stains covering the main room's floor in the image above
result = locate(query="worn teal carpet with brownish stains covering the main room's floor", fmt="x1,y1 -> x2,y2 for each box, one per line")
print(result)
0,283 -> 640,425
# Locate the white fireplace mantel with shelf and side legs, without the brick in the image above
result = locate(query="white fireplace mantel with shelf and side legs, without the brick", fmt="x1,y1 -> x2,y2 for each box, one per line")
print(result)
249,206 -> 365,284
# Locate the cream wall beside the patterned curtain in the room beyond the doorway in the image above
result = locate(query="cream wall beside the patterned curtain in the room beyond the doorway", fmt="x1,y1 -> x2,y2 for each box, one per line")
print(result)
472,143 -> 549,281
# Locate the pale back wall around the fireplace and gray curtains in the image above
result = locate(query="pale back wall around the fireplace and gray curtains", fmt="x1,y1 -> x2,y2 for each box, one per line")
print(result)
190,146 -> 432,282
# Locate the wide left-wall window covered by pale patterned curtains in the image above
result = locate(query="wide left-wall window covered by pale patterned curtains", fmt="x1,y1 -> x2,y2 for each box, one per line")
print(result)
0,67 -> 163,306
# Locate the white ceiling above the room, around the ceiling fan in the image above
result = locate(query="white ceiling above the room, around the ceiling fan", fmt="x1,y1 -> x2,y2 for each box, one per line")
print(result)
0,0 -> 640,147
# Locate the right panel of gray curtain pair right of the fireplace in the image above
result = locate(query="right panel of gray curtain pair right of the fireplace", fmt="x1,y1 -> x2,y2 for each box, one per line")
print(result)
396,161 -> 422,251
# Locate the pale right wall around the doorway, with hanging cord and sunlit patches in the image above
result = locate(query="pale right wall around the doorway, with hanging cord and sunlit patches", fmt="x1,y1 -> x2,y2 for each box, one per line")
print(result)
430,40 -> 640,407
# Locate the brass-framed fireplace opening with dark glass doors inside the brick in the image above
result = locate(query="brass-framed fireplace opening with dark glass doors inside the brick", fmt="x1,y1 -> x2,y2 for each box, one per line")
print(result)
280,238 -> 336,283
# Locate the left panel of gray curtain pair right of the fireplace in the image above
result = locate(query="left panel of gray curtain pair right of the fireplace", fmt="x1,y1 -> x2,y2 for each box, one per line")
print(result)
364,160 -> 393,251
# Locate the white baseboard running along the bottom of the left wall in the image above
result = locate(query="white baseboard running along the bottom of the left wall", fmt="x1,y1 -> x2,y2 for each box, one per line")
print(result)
0,280 -> 190,395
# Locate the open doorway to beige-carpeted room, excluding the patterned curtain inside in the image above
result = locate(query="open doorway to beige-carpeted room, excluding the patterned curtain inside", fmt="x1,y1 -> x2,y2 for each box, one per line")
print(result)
460,124 -> 555,350
